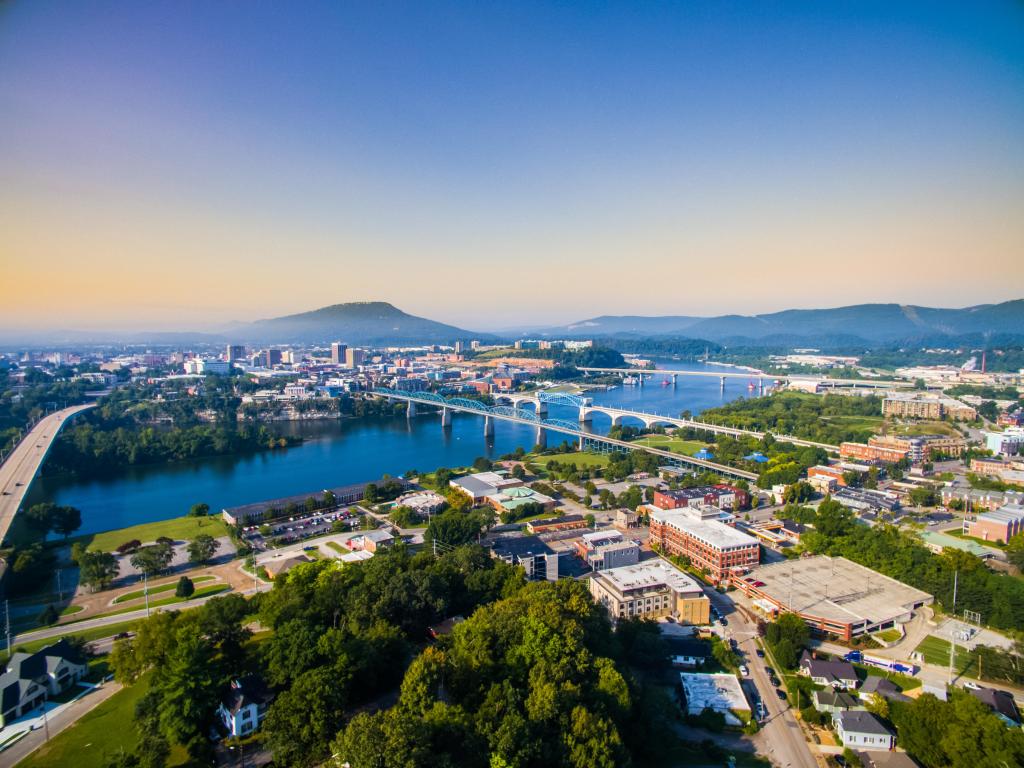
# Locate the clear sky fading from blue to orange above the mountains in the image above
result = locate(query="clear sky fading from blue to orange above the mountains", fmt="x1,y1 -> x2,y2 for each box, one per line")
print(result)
0,0 -> 1024,330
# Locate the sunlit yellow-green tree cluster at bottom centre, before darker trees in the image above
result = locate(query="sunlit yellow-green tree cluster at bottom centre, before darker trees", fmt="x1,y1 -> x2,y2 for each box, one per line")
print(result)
331,580 -> 672,768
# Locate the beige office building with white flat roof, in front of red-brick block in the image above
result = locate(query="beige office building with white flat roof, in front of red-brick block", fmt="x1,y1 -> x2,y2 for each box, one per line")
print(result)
590,558 -> 711,624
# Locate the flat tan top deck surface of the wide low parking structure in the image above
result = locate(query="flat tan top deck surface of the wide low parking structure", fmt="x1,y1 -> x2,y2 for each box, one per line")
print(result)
754,555 -> 932,624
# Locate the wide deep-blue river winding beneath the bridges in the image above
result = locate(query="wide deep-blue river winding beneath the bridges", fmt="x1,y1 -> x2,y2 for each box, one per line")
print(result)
26,360 -> 770,534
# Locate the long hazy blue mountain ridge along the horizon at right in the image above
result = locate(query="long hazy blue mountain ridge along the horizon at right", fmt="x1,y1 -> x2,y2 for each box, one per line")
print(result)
539,299 -> 1024,344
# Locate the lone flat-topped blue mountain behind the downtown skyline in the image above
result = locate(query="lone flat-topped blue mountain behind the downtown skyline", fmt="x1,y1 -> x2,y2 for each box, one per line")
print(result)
232,301 -> 492,345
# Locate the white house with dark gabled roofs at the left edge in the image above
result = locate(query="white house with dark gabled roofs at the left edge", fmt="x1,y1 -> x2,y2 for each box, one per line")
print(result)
0,639 -> 88,727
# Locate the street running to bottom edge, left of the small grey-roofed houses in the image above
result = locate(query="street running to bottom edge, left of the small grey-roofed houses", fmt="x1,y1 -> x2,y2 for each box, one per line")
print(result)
708,590 -> 818,768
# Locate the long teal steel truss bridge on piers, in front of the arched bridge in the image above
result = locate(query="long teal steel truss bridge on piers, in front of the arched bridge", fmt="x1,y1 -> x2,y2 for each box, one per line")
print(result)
369,387 -> 758,481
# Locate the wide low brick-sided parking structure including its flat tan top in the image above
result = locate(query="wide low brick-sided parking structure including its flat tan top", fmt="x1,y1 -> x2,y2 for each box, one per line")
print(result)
732,555 -> 933,642
